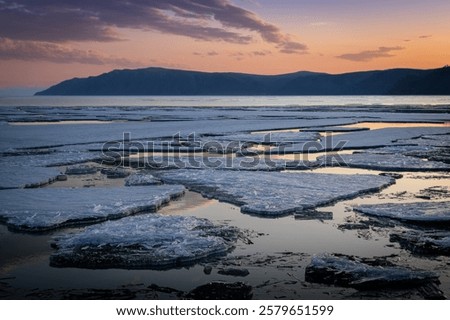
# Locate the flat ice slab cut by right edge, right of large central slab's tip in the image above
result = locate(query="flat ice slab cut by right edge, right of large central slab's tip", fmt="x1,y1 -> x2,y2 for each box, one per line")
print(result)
354,201 -> 450,227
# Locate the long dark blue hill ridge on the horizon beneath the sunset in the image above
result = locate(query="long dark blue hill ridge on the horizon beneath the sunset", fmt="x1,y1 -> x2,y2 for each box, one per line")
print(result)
36,67 -> 450,95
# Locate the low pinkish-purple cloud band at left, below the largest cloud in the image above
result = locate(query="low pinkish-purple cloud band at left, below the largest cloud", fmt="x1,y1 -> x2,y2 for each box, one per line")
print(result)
0,38 -> 140,67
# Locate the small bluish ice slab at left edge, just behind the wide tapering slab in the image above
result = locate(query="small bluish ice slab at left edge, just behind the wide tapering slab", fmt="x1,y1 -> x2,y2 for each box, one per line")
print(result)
0,157 -> 60,189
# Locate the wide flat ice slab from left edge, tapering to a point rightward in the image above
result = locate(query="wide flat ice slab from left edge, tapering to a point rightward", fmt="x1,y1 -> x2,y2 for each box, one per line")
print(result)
0,185 -> 184,232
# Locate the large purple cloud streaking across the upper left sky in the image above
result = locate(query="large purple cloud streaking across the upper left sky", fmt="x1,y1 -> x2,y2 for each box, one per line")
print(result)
0,0 -> 307,53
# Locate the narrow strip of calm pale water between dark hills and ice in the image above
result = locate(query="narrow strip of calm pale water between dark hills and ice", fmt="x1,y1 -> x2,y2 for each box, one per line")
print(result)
0,96 -> 450,107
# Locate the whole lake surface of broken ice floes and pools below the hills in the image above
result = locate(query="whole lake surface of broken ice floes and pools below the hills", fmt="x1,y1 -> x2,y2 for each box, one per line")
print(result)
0,97 -> 450,299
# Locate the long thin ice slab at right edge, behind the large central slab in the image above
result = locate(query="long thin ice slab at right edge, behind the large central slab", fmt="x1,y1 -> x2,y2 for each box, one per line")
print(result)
317,152 -> 450,171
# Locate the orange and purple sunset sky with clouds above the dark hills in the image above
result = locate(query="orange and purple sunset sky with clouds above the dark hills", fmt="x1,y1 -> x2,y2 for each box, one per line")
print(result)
0,0 -> 450,89
